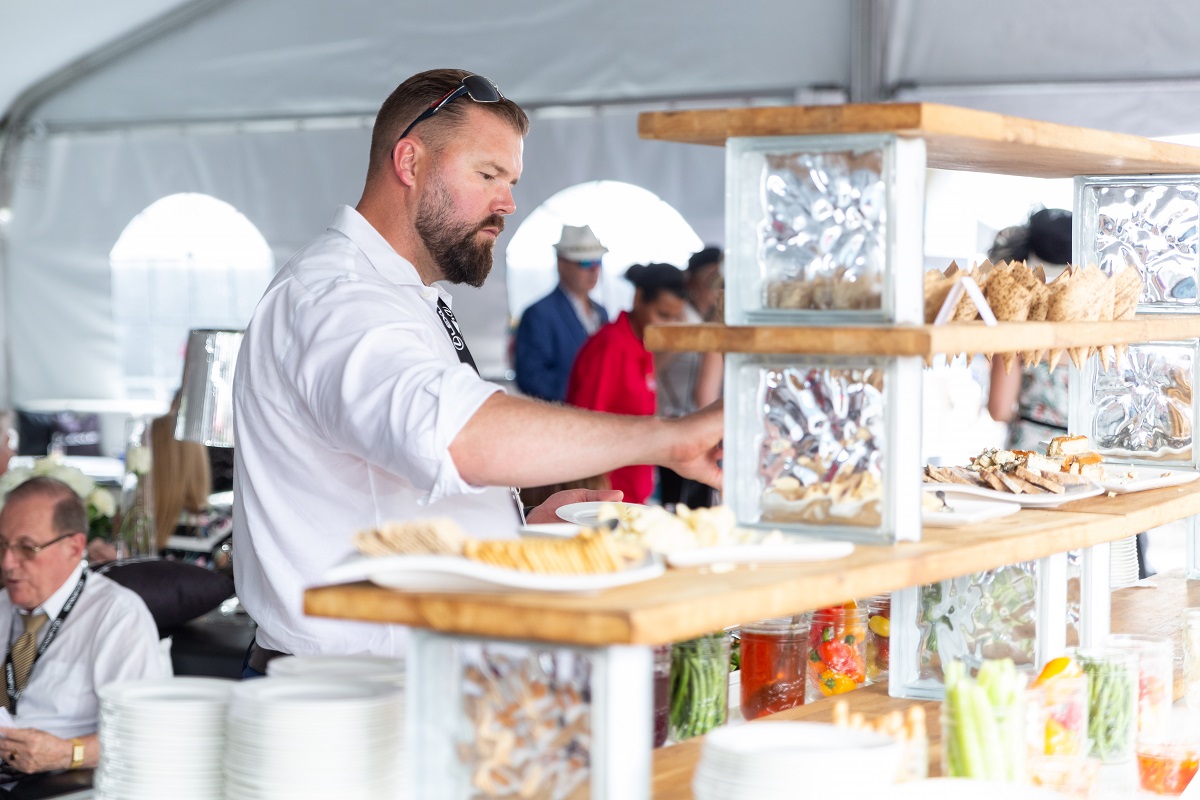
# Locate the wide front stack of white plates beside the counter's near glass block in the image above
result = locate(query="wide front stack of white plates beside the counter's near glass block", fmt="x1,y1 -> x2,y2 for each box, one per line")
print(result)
226,678 -> 404,800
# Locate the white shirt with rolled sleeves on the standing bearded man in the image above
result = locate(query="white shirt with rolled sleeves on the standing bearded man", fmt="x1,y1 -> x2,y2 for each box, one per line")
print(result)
233,206 -> 518,656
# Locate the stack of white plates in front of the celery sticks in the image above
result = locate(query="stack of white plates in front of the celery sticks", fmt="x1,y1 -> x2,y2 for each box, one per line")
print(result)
691,722 -> 902,800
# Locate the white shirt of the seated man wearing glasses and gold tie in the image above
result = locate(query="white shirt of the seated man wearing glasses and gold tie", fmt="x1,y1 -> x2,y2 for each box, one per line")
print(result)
0,564 -> 167,739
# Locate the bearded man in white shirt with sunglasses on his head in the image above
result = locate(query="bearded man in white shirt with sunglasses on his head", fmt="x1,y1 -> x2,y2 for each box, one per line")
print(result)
234,70 -> 722,675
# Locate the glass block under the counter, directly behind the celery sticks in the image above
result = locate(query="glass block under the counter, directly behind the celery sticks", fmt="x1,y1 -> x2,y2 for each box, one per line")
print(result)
888,561 -> 1039,699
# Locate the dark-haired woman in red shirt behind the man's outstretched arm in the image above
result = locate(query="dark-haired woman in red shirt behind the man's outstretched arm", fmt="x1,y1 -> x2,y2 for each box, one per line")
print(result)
566,264 -> 686,503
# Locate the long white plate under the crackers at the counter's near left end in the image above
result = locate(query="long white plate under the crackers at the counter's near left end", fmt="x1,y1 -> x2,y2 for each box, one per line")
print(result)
324,555 -> 664,593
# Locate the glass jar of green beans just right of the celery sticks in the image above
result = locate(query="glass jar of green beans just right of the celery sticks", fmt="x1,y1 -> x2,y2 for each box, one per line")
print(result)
1074,646 -> 1138,764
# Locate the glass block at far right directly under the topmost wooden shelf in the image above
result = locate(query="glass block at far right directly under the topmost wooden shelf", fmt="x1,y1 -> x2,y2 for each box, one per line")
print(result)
1075,175 -> 1200,313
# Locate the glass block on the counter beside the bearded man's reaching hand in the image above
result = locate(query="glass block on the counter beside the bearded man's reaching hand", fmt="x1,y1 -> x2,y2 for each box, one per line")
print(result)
725,354 -> 920,542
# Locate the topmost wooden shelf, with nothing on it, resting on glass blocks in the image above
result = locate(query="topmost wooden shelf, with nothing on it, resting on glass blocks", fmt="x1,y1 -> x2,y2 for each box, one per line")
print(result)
637,103 -> 1200,178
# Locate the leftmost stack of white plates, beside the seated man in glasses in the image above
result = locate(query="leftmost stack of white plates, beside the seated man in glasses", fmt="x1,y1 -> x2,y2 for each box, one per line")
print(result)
95,678 -> 235,800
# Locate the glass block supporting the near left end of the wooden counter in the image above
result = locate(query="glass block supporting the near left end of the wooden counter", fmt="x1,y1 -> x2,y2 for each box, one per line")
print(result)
407,631 -> 595,800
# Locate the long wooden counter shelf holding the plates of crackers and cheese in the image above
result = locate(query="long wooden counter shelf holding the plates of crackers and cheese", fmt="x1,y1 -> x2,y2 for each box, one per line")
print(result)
305,481 -> 1200,646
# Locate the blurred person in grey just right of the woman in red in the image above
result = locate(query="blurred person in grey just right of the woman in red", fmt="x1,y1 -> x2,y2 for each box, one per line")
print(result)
654,247 -> 724,509
